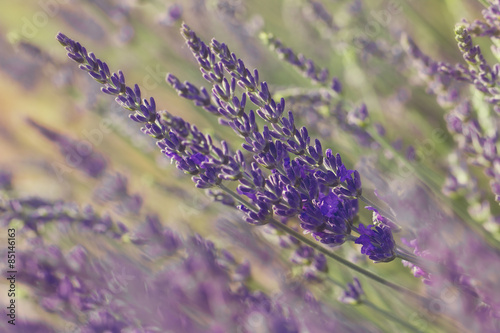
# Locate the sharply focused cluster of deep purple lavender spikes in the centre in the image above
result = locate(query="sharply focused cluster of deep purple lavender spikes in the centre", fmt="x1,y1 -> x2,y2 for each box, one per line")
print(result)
57,25 -> 395,261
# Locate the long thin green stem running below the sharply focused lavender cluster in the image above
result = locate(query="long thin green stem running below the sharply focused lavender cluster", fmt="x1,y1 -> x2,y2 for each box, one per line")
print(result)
219,184 -> 428,304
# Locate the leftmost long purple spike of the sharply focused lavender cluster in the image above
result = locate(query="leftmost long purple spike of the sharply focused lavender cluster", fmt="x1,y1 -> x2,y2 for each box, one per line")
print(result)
57,33 -> 250,205
